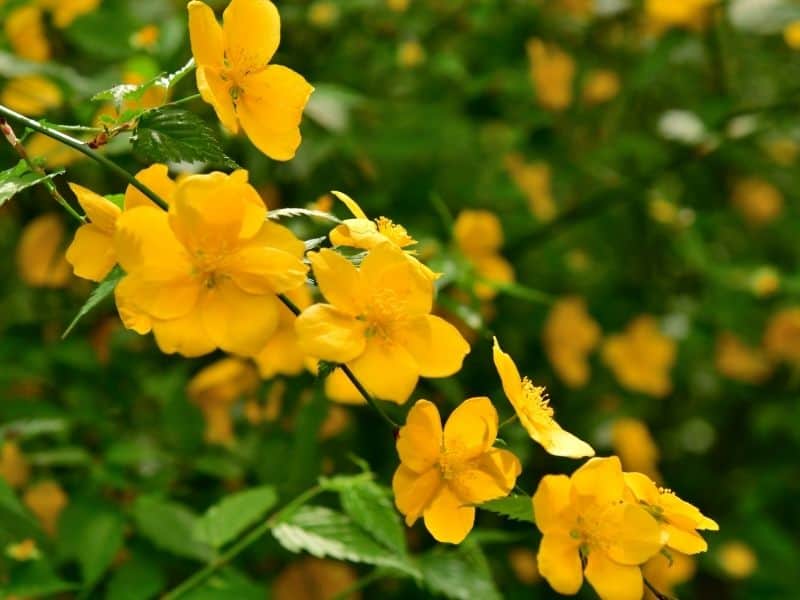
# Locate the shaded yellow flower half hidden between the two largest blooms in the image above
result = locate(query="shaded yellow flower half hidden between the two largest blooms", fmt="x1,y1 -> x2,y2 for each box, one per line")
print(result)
253,285 -> 312,379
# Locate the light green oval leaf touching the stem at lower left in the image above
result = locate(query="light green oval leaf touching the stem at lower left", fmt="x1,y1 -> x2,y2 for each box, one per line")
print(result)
195,486 -> 278,548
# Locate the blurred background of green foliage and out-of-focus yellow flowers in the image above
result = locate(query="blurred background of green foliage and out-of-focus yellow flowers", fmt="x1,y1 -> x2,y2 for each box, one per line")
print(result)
0,0 -> 800,599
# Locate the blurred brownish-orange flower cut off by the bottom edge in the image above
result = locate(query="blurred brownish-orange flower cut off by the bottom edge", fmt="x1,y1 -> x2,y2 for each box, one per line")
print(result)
272,556 -> 361,600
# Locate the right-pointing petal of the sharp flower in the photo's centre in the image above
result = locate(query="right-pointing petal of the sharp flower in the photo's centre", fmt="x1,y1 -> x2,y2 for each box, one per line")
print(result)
402,315 -> 469,377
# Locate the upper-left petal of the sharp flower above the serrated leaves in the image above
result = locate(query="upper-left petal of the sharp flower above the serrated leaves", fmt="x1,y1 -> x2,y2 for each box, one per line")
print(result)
396,400 -> 442,473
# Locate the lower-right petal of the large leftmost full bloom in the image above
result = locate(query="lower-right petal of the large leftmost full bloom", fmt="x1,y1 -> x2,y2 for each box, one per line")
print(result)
200,280 -> 280,356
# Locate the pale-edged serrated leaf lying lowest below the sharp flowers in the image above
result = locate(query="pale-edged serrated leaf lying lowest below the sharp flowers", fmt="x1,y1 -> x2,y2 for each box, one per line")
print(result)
272,506 -> 419,577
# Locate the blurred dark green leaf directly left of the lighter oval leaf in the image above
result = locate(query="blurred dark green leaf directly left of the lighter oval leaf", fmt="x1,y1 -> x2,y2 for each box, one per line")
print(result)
133,496 -> 214,562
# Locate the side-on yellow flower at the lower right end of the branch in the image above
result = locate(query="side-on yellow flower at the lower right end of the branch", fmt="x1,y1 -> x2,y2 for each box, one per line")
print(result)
624,473 -> 719,554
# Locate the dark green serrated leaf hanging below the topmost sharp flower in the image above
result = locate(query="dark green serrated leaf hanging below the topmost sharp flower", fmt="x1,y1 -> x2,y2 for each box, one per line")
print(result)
131,107 -> 238,169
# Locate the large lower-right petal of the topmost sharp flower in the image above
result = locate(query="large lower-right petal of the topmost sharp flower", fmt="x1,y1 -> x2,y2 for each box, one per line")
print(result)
236,65 -> 314,160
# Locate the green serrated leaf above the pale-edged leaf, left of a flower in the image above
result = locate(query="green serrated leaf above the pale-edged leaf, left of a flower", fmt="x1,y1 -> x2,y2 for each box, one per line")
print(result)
339,481 -> 406,554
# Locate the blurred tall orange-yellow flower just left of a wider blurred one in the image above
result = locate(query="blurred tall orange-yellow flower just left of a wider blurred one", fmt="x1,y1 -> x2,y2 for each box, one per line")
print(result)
542,296 -> 601,388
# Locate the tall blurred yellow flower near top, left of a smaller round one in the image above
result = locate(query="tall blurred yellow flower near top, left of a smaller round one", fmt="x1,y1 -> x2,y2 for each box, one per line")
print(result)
526,38 -> 575,111
